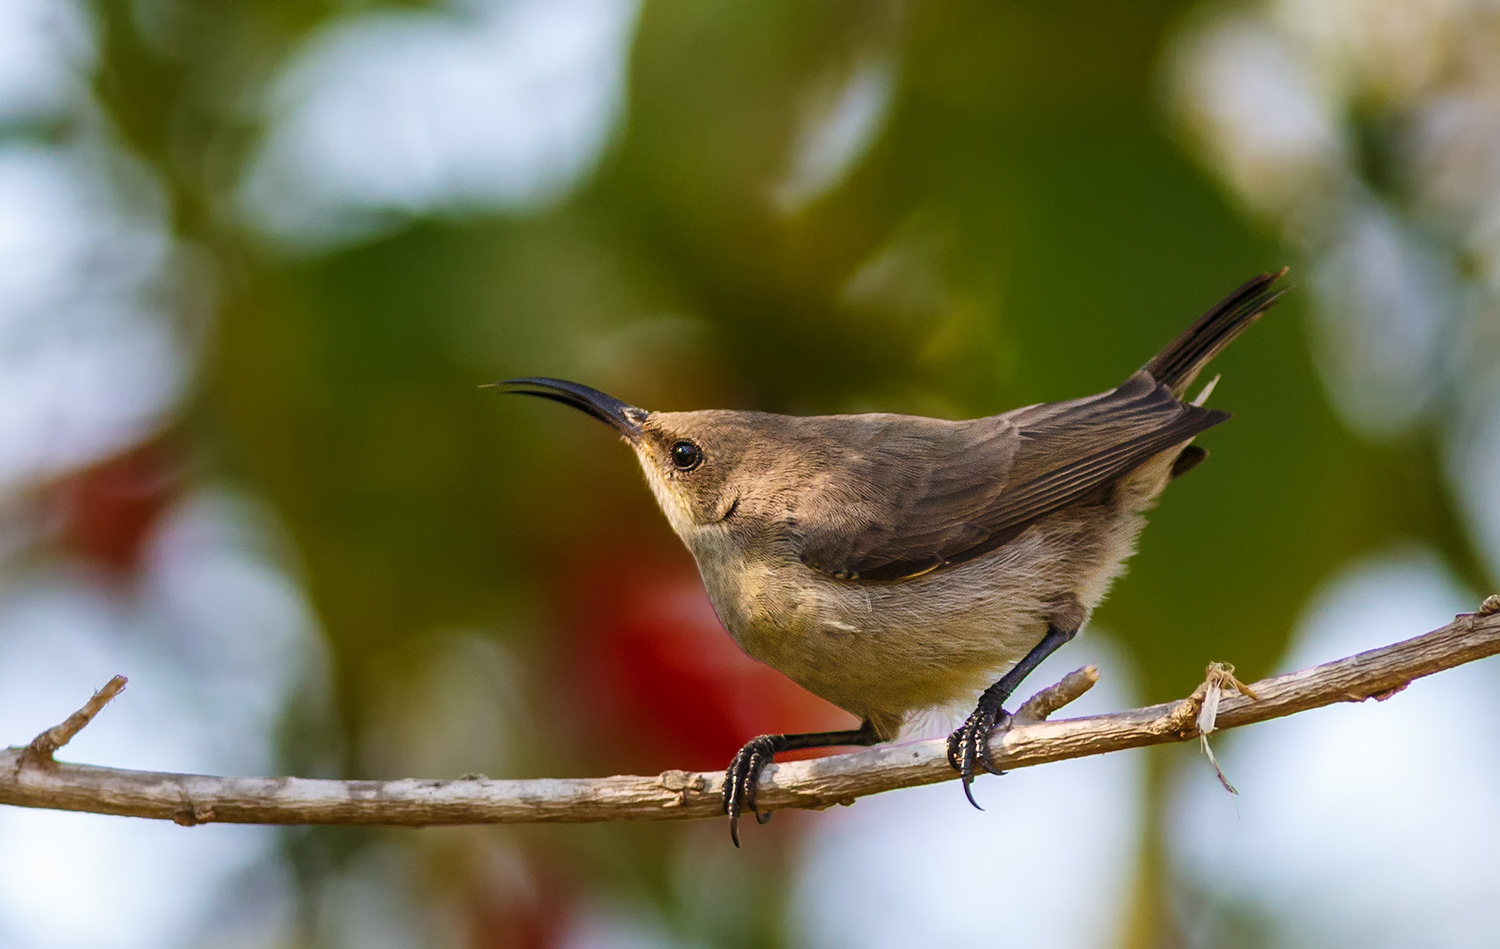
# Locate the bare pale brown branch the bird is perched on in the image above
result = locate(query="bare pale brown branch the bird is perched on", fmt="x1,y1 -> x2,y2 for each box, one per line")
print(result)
0,597 -> 1500,826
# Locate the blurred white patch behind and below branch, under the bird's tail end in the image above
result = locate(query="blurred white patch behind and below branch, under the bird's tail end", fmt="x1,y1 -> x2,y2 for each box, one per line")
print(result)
792,633 -> 1145,949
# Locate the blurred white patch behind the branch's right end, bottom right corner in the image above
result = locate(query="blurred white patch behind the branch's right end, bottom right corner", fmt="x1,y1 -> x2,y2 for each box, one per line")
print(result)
1169,552 -> 1500,949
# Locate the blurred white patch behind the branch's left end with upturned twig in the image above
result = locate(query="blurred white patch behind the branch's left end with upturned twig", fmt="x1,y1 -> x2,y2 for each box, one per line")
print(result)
0,582 -> 275,949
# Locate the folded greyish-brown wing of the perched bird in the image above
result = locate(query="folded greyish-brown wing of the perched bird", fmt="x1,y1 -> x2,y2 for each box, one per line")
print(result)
788,372 -> 1229,580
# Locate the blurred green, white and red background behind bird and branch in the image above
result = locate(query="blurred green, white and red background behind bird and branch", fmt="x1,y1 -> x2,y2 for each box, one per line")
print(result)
0,0 -> 1500,949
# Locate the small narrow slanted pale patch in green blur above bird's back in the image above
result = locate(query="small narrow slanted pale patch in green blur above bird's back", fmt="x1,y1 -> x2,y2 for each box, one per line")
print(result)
776,58 -> 896,214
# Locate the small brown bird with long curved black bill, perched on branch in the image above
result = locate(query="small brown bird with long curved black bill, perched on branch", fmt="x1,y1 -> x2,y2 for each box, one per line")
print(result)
489,268 -> 1287,847
